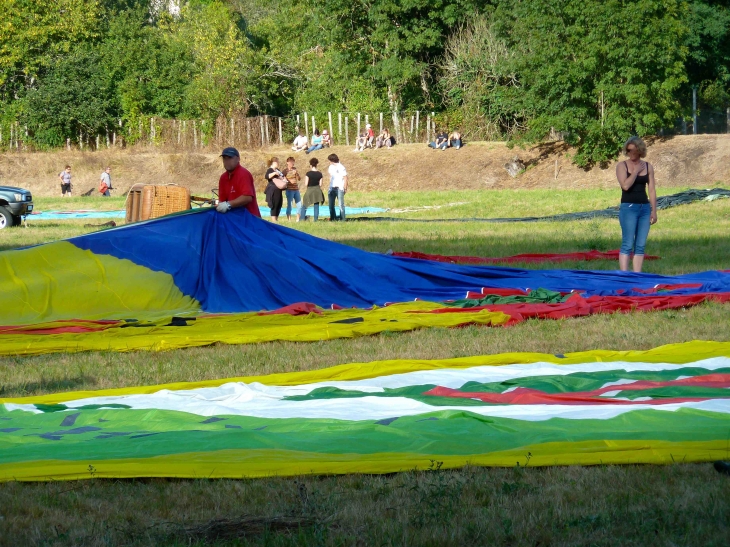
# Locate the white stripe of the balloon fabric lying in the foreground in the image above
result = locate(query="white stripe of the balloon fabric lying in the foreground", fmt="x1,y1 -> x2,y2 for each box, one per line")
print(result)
5,357 -> 730,421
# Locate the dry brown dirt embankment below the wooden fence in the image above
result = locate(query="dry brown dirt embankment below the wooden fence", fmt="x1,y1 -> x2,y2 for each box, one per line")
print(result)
0,135 -> 730,196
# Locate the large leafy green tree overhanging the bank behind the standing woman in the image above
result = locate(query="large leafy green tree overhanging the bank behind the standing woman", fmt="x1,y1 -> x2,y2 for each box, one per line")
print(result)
494,0 -> 687,166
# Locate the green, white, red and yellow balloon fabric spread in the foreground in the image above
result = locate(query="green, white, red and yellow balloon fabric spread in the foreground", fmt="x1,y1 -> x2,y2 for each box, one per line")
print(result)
0,342 -> 730,481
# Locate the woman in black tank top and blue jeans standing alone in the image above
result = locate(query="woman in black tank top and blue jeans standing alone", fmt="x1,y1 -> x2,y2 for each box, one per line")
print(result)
616,137 -> 657,272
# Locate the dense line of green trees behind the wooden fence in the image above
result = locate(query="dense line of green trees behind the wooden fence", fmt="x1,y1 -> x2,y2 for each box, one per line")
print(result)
0,0 -> 730,165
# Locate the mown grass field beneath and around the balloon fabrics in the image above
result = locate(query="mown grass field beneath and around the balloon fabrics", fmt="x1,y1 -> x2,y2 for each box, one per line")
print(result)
0,187 -> 730,546
